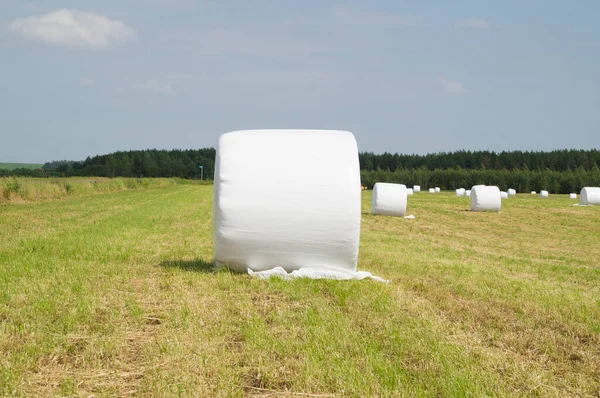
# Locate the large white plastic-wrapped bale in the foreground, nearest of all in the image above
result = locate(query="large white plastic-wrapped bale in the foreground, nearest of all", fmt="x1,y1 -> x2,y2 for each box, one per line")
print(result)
213,130 -> 361,272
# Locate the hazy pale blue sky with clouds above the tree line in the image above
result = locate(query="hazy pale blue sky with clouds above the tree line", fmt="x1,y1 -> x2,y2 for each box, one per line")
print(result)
0,0 -> 600,162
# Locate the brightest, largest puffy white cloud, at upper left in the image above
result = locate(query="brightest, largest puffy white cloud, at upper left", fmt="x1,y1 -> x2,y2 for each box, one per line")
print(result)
8,9 -> 136,49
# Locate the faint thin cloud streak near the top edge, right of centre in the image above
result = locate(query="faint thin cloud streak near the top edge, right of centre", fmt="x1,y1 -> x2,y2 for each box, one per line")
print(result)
333,5 -> 422,28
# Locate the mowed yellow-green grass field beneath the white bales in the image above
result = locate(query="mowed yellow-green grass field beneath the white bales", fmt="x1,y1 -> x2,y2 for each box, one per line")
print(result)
0,185 -> 600,397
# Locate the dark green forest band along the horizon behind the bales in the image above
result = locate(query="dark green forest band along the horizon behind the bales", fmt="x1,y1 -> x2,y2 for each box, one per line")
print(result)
0,148 -> 600,193
